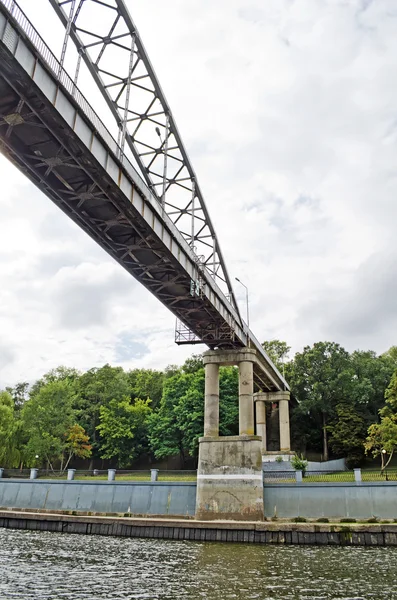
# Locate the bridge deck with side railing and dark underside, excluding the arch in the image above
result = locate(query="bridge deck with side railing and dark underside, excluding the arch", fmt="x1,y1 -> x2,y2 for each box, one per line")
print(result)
0,0 -> 288,390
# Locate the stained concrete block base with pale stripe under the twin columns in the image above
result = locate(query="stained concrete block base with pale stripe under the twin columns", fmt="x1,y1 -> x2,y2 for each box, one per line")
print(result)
196,435 -> 264,521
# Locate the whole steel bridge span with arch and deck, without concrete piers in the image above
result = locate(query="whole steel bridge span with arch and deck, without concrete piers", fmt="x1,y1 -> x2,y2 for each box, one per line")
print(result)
0,0 -> 288,390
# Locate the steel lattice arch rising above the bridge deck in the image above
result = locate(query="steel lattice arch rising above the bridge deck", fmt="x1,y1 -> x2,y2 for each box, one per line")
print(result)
49,0 -> 238,311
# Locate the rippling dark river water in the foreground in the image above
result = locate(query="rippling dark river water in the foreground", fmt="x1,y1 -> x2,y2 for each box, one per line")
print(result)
0,529 -> 397,600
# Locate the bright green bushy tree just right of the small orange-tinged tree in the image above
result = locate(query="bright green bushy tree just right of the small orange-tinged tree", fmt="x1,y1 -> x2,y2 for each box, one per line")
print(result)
97,397 -> 151,467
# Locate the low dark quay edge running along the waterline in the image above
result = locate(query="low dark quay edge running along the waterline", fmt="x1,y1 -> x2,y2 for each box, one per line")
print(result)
0,510 -> 397,546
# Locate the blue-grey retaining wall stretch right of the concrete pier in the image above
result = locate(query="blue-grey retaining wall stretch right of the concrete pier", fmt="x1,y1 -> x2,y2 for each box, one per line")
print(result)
264,481 -> 397,519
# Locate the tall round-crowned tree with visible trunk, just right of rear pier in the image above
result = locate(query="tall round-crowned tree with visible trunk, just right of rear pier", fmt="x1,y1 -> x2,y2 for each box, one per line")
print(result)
289,342 -> 353,460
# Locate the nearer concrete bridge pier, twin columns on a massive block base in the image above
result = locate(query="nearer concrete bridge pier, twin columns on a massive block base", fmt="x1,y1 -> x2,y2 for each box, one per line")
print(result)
196,348 -> 264,521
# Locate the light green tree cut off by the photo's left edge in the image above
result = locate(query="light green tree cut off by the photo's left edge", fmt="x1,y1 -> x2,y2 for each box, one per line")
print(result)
0,391 -> 20,467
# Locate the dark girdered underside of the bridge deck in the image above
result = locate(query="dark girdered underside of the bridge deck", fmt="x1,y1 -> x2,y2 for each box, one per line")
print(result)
0,46 -> 237,347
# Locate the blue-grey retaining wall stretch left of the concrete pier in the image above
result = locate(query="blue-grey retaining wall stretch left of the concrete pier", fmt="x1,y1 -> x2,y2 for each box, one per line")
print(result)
0,479 -> 196,516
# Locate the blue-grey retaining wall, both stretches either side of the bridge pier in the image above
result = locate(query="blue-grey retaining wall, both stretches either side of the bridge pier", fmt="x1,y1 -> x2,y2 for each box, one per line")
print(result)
0,479 -> 397,519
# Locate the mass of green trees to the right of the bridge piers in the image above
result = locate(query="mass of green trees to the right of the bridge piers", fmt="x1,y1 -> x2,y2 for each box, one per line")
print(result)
263,340 -> 397,468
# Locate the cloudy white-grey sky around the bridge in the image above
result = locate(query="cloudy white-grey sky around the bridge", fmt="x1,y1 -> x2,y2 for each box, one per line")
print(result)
0,0 -> 397,389
